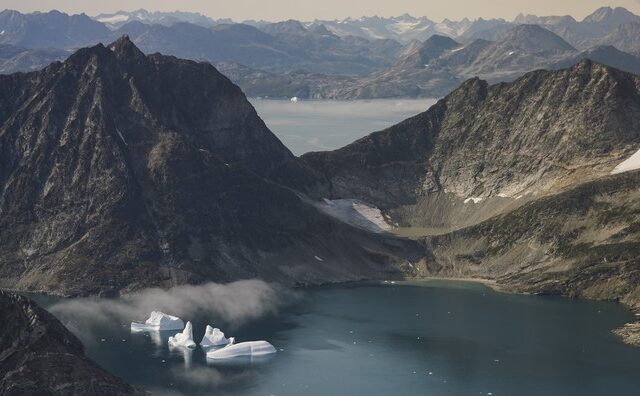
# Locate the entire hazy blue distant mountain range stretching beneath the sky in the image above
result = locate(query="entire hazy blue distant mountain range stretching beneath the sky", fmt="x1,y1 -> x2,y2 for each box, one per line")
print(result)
0,7 -> 640,99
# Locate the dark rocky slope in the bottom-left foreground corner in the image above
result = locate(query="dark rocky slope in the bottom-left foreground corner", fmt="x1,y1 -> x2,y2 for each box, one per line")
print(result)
0,290 -> 145,395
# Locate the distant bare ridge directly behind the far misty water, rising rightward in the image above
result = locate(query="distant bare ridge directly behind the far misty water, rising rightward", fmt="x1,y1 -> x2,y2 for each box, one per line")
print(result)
222,25 -> 640,99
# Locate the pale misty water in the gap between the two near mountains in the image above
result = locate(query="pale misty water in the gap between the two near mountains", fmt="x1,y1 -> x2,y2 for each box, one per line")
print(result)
251,99 -> 437,155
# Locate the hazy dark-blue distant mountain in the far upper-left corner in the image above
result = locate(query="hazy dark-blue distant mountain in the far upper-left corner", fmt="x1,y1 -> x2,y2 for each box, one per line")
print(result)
0,10 -> 109,49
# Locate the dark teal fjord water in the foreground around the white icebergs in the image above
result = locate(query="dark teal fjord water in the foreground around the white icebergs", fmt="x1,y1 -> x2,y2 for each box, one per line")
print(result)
40,281 -> 640,396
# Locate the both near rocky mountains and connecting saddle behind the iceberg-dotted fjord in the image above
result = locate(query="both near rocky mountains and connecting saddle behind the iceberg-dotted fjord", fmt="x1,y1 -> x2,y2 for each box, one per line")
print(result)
0,36 -> 640,346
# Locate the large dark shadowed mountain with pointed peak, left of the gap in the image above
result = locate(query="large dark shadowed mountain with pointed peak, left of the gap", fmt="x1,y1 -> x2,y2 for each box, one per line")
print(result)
0,37 -> 420,294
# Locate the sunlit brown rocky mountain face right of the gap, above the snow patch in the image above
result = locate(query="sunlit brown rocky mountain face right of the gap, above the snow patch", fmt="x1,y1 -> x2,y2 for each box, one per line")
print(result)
303,61 -> 640,227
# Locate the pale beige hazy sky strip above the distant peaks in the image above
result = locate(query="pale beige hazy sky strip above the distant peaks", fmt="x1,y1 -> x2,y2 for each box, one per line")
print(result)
0,0 -> 640,21
